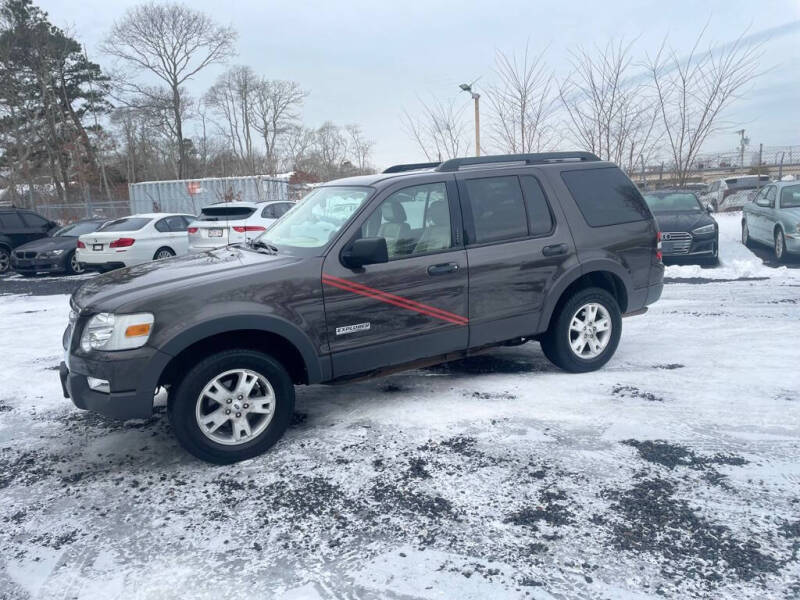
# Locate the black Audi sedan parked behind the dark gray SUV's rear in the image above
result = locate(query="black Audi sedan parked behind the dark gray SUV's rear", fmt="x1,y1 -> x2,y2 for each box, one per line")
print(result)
644,190 -> 719,264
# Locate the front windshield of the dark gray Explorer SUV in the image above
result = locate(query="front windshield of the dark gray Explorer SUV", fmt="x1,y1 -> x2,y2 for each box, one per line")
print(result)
259,186 -> 373,248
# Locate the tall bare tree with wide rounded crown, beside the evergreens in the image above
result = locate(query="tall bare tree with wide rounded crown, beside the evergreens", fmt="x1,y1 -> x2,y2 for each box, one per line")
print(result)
102,2 -> 236,179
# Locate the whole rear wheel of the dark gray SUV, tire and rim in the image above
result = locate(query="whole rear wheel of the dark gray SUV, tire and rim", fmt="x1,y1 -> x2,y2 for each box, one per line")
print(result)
542,288 -> 622,373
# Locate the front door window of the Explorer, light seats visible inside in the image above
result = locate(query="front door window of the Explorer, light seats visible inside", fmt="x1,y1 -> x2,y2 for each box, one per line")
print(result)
361,183 -> 452,260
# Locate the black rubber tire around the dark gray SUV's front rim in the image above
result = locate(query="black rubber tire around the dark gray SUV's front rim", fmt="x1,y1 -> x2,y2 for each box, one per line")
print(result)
167,350 -> 294,465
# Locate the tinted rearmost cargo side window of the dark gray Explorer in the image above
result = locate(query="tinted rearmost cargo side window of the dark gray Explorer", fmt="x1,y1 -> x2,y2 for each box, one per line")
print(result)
561,167 -> 650,227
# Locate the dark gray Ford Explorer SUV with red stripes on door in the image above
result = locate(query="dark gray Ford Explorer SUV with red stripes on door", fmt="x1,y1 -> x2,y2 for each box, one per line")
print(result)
61,152 -> 664,463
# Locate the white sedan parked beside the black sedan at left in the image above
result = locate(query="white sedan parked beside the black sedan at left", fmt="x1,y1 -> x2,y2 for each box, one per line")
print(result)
76,213 -> 195,271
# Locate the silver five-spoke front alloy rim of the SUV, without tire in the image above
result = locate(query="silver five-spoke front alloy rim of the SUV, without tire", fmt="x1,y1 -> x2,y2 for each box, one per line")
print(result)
195,369 -> 275,446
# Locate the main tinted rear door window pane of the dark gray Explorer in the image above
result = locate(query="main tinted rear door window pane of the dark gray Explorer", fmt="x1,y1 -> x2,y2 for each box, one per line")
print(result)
464,175 -> 528,244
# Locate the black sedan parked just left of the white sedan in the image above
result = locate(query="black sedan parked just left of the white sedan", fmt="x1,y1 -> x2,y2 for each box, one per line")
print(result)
11,219 -> 106,277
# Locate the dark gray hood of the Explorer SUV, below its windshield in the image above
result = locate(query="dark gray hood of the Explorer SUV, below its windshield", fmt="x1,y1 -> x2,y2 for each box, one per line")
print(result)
72,247 -> 302,312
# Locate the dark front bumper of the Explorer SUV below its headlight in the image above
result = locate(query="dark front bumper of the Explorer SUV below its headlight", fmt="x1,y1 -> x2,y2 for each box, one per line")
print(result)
59,347 -> 171,419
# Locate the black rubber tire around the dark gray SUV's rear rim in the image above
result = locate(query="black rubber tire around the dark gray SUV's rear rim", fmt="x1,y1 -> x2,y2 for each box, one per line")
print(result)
541,288 -> 622,373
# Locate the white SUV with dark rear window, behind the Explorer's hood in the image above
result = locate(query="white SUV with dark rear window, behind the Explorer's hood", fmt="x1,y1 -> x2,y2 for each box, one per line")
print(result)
189,201 -> 294,252
